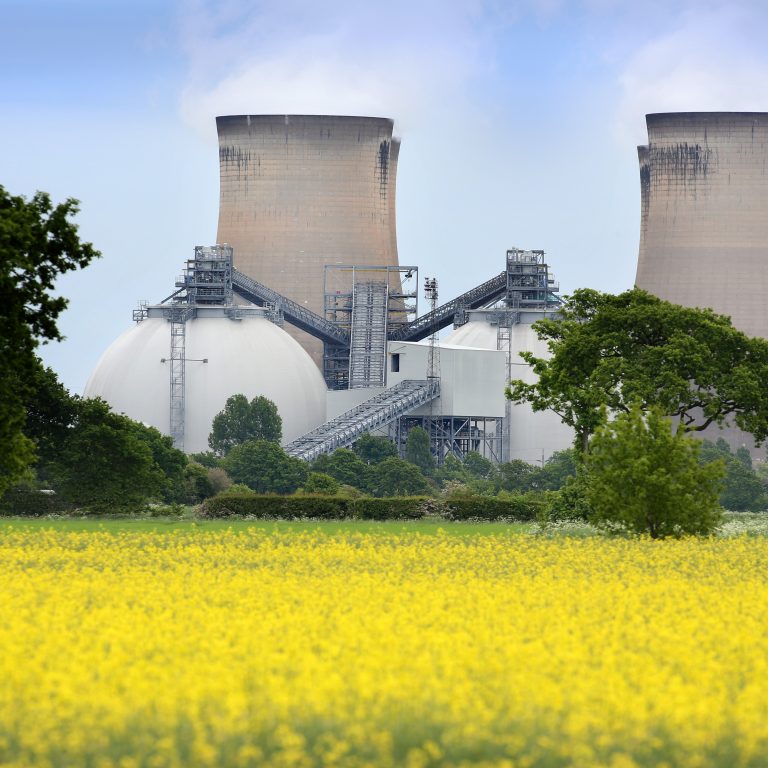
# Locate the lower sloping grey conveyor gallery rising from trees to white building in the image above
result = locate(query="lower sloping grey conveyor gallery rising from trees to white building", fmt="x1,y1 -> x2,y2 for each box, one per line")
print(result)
285,379 -> 440,461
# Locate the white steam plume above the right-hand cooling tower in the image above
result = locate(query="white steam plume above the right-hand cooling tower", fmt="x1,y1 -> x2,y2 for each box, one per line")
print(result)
617,0 -> 768,144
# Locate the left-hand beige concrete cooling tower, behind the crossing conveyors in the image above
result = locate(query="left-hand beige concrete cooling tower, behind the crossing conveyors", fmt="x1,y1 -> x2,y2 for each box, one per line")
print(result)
216,115 -> 400,365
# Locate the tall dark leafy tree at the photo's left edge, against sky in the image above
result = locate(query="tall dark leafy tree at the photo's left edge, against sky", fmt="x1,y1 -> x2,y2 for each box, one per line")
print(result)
0,186 -> 99,493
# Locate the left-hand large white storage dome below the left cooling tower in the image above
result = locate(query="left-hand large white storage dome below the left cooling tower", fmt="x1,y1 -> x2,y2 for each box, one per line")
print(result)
85,316 -> 326,453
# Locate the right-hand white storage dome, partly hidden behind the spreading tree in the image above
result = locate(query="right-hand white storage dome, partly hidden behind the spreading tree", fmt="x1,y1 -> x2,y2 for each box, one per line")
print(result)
444,320 -> 574,464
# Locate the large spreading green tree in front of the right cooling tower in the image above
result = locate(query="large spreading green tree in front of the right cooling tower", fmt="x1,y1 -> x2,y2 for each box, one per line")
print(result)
507,289 -> 768,454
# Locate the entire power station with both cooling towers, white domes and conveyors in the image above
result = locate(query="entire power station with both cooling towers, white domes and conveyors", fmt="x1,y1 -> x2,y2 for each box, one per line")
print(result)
85,112 -> 768,463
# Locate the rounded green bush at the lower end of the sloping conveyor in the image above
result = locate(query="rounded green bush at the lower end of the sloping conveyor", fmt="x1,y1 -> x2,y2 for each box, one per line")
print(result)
222,440 -> 308,494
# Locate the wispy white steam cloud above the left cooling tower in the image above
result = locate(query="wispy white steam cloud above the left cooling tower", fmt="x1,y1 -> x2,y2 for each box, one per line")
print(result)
181,0 -> 507,132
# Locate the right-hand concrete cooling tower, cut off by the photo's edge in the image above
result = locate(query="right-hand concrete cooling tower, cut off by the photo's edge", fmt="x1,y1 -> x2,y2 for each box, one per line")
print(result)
636,112 -> 768,337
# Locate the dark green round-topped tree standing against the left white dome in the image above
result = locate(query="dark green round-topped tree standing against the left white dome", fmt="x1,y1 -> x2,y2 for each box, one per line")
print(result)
208,395 -> 283,456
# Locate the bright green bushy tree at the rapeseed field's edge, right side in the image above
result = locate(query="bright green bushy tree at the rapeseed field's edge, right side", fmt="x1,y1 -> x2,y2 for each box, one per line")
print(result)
586,404 -> 724,539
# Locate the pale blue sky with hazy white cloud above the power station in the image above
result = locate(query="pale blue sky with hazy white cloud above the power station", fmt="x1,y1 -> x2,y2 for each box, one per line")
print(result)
0,0 -> 768,392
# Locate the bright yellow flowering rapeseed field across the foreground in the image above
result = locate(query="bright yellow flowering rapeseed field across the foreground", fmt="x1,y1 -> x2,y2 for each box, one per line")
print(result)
0,530 -> 768,768
